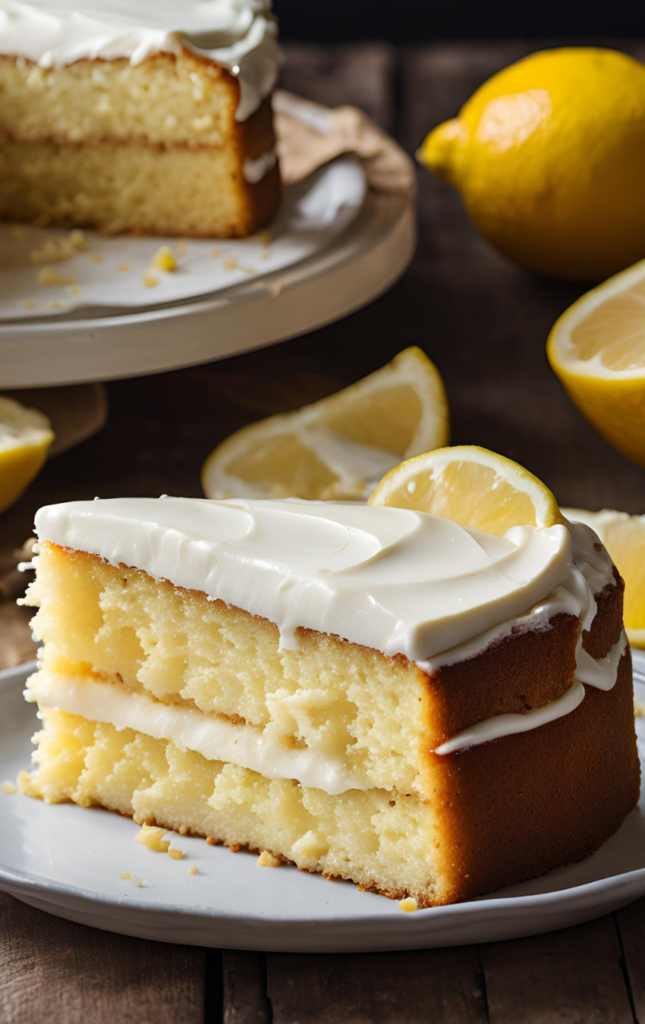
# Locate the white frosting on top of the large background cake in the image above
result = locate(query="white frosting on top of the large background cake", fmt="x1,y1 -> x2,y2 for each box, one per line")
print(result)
0,0 -> 280,121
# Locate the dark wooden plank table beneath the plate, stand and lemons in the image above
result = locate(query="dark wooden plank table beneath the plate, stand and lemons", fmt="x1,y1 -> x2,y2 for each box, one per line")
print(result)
0,42 -> 645,1024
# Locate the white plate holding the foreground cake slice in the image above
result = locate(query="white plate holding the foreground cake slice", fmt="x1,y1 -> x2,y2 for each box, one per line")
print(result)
0,652 -> 645,952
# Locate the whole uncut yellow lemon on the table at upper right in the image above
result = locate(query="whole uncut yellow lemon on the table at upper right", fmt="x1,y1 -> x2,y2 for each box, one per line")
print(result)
419,47 -> 645,281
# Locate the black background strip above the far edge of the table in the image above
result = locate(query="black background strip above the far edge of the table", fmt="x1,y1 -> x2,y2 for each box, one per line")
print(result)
273,0 -> 645,43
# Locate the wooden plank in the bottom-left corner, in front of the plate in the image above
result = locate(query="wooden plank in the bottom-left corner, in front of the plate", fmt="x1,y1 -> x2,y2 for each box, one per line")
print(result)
0,893 -> 204,1024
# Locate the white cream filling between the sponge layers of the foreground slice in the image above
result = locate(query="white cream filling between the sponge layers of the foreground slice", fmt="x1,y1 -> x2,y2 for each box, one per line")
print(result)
25,671 -> 372,796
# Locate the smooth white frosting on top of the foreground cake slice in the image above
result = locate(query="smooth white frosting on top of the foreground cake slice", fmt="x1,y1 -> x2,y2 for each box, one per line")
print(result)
31,497 -> 610,662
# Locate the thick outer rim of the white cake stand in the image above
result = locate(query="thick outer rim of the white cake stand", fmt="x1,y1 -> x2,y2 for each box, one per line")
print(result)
0,193 -> 416,390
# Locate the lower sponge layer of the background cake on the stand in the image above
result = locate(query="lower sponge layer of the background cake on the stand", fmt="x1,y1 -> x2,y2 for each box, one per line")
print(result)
0,130 -> 280,238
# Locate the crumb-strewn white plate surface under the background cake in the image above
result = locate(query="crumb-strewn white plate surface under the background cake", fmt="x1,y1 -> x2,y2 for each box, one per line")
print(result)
0,156 -> 367,322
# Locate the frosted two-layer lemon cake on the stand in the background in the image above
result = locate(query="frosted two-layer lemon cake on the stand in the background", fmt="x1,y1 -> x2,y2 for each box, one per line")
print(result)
0,0 -> 280,238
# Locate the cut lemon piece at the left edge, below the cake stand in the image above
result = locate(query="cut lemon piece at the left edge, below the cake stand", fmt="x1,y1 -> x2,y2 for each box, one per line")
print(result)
0,396 -> 54,512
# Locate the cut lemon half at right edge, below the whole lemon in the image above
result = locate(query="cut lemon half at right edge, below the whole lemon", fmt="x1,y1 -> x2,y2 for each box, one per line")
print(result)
547,260 -> 645,466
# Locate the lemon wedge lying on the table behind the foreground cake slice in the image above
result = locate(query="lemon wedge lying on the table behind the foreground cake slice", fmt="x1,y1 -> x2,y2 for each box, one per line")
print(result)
202,348 -> 448,500
